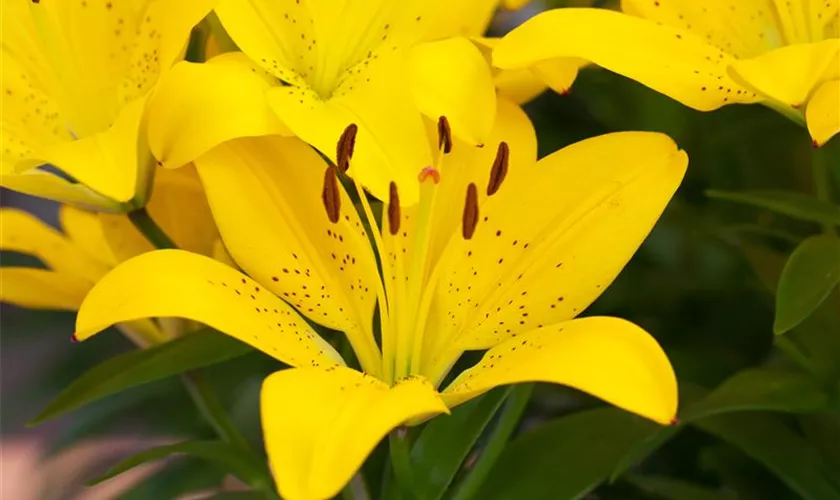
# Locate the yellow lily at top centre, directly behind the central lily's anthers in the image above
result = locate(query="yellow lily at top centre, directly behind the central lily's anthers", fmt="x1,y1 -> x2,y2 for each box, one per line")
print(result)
149,0 -> 496,205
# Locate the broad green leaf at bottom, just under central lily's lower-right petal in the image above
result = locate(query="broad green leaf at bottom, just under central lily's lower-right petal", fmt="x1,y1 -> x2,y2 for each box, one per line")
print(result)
475,408 -> 661,500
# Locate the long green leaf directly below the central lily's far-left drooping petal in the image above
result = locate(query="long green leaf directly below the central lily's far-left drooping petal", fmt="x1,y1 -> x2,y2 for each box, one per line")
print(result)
27,329 -> 253,426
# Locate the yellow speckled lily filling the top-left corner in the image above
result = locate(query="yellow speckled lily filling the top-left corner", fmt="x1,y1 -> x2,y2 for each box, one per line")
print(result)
0,0 -> 211,211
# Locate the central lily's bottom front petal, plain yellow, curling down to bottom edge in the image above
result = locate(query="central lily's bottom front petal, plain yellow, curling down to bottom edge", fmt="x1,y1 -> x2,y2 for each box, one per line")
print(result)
260,367 -> 448,500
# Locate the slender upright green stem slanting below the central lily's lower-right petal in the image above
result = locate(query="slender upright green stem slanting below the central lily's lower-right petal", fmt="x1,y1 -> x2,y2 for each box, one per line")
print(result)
452,384 -> 534,500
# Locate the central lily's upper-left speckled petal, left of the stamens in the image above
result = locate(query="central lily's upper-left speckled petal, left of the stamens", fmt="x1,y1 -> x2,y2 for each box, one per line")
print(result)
196,136 -> 380,374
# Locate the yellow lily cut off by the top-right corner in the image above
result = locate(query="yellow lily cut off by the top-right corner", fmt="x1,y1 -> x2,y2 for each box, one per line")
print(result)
493,0 -> 840,146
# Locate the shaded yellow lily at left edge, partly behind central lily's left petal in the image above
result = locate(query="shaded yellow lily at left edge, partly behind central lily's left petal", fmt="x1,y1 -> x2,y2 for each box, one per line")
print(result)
0,167 -> 218,347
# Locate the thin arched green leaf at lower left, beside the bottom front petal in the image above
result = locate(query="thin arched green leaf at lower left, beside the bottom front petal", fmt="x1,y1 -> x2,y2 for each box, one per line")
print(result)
87,441 -> 270,487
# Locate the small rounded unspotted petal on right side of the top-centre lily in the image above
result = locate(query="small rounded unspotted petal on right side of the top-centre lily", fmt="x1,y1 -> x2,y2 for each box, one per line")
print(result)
410,37 -> 496,146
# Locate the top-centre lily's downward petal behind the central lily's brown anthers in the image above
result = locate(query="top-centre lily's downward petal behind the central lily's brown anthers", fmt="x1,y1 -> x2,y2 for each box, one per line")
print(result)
268,56 -> 431,206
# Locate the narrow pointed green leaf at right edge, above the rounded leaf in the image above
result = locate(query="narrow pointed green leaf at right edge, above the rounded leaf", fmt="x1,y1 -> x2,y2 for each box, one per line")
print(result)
706,190 -> 840,225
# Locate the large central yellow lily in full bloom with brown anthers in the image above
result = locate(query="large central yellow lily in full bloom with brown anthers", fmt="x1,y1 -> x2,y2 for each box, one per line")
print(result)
76,100 -> 687,500
